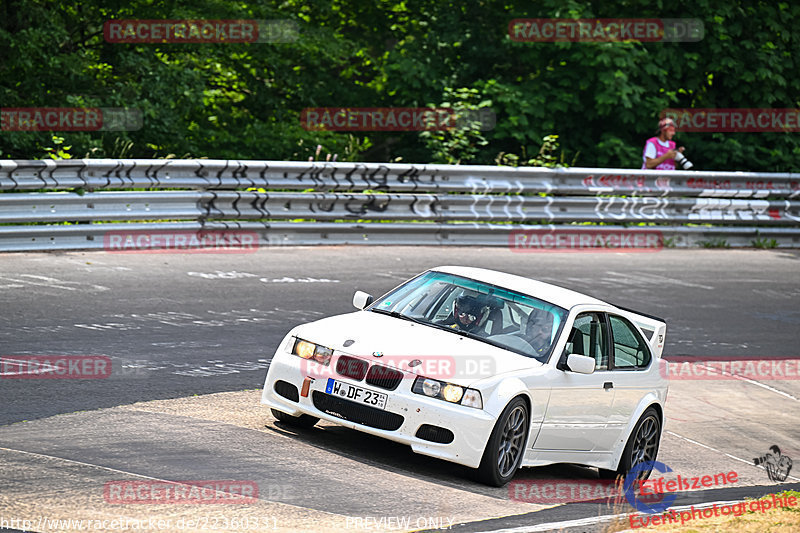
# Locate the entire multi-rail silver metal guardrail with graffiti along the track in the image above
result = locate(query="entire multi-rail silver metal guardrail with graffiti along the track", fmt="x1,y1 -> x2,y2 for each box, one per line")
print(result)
0,159 -> 800,251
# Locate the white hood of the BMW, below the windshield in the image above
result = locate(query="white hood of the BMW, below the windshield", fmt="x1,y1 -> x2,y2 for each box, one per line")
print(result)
294,311 -> 542,386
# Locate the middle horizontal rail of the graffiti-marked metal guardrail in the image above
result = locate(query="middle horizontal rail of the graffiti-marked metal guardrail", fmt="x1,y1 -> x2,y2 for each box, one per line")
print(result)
0,191 -> 800,226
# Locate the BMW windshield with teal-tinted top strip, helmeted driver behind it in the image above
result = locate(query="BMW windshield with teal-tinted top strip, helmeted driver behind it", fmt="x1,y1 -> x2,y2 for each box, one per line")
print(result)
368,272 -> 567,362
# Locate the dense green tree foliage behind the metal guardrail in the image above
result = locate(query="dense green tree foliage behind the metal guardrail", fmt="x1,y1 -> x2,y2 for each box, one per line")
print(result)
0,0 -> 800,172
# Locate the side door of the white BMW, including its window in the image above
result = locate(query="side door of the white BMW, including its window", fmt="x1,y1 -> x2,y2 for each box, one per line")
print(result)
533,312 -> 615,451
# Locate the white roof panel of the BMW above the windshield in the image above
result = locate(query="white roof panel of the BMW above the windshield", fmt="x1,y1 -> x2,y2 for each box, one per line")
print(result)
431,266 -> 614,309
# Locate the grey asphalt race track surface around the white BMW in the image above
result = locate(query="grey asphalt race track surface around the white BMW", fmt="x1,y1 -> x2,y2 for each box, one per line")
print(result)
0,247 -> 800,531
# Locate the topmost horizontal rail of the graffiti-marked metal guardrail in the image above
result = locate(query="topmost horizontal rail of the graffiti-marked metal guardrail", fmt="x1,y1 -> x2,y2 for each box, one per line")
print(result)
0,159 -> 800,198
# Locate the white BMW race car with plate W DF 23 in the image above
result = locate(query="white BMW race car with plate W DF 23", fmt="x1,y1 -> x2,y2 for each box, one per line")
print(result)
261,266 -> 668,486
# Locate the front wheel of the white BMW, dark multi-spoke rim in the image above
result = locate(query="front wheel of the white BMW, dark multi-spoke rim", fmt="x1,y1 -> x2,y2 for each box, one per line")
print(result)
477,397 -> 530,487
